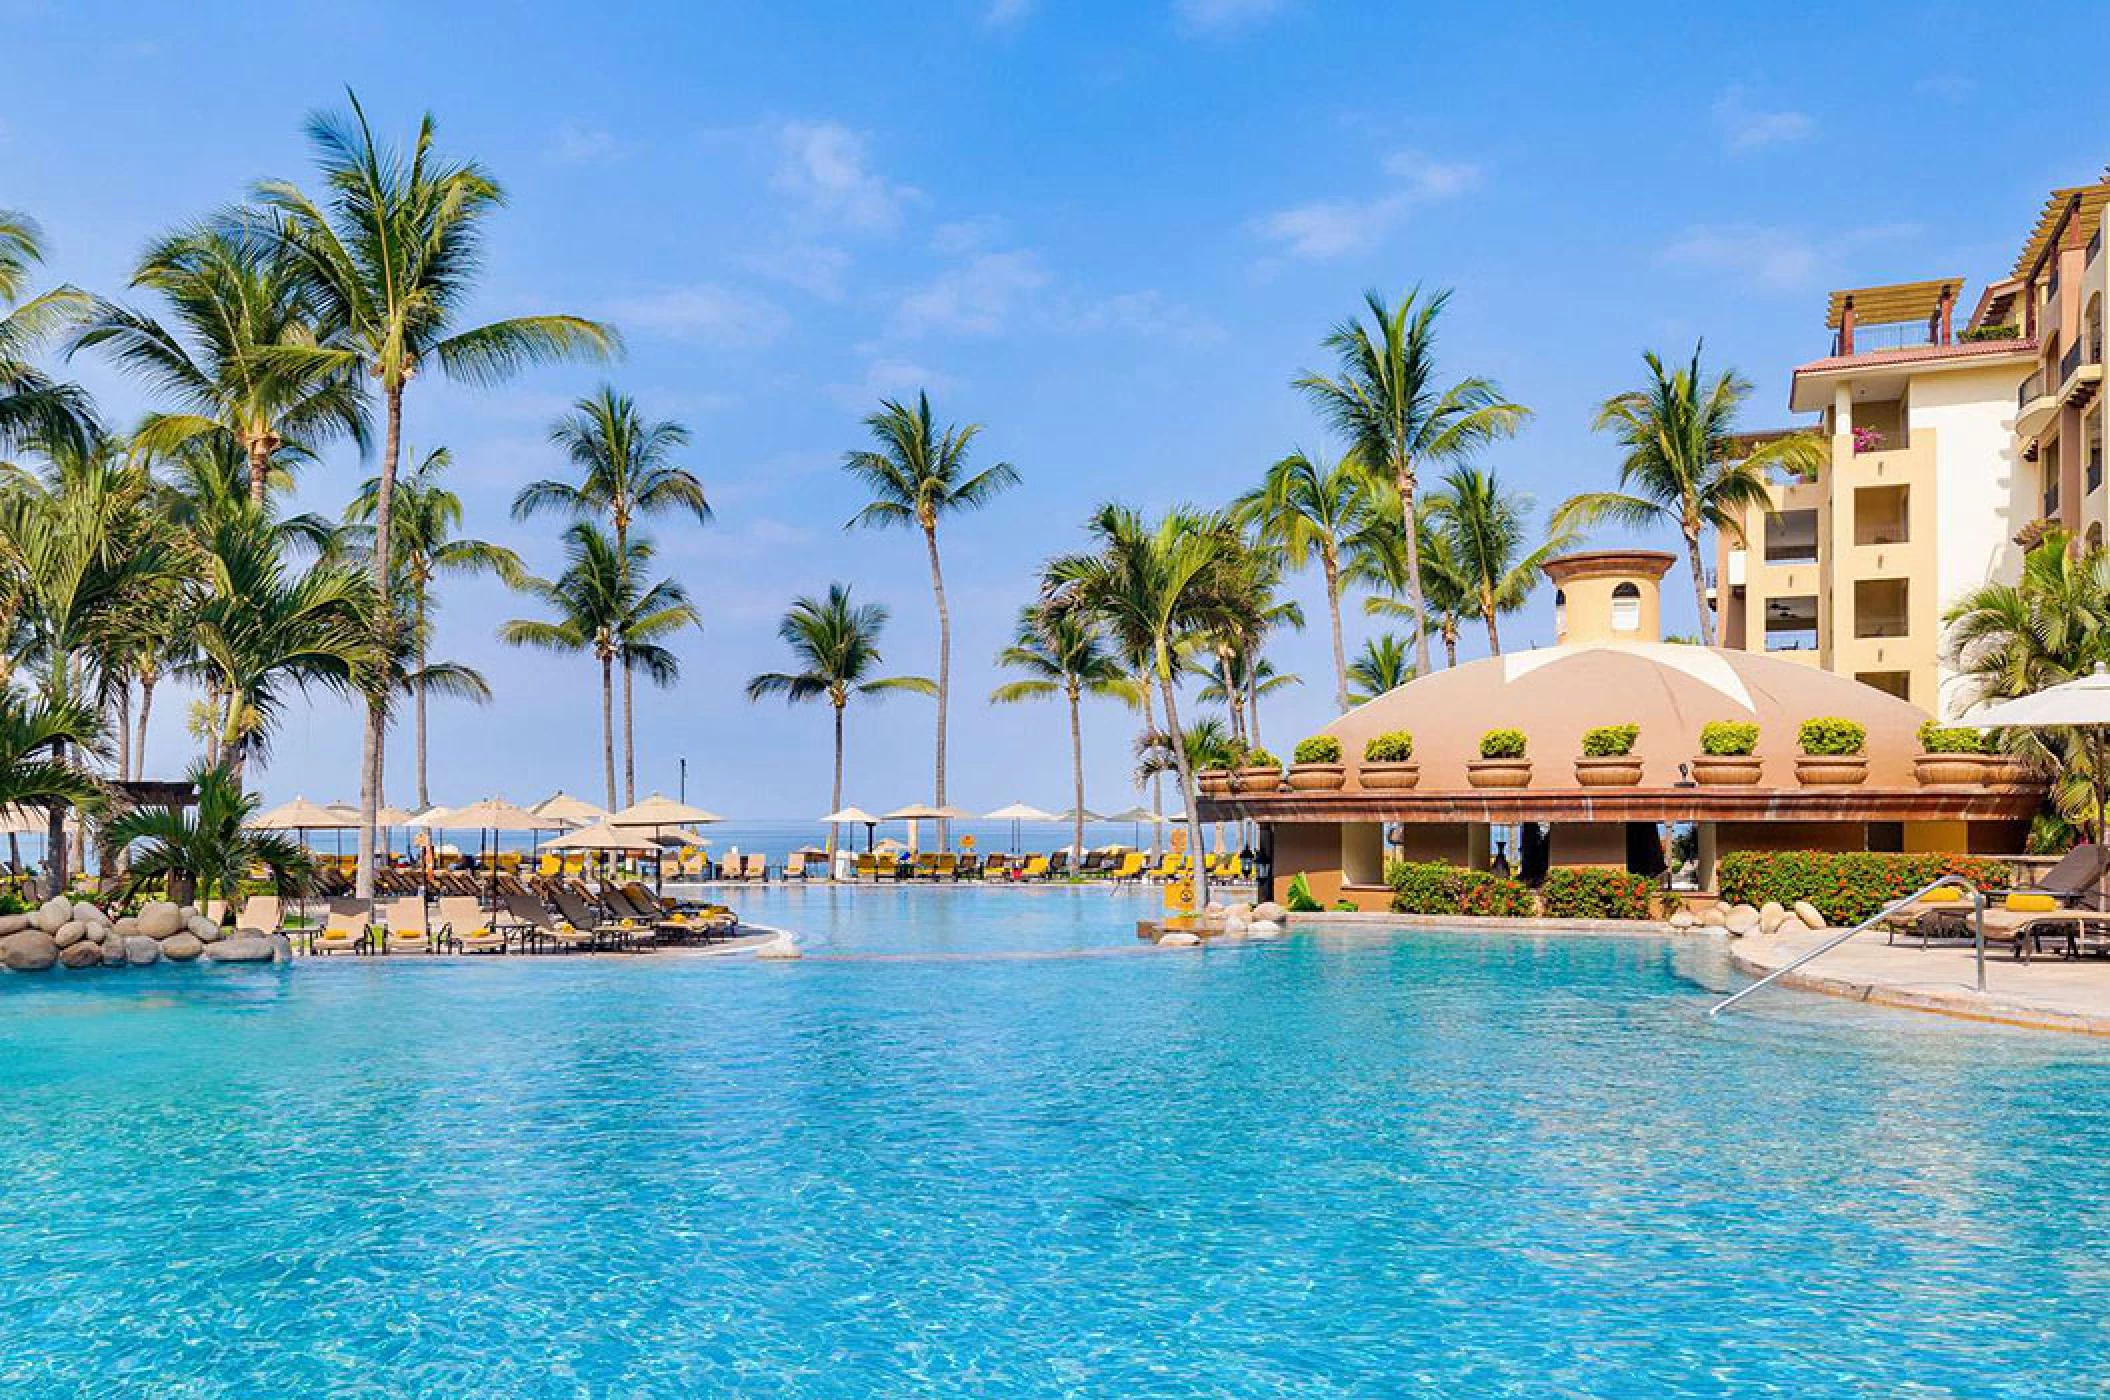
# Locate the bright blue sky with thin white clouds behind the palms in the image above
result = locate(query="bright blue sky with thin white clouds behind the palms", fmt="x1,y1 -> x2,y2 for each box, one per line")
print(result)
0,0 -> 2106,816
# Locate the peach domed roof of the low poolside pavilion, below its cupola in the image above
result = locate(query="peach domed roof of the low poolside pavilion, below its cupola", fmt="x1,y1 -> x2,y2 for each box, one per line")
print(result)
1323,641 -> 1929,791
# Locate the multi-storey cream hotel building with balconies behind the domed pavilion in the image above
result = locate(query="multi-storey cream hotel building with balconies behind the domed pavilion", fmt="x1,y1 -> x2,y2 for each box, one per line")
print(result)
1713,183 -> 2110,717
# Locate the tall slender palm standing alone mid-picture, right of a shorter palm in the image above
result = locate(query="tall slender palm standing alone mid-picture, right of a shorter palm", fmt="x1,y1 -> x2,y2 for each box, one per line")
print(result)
842,394 -> 1019,843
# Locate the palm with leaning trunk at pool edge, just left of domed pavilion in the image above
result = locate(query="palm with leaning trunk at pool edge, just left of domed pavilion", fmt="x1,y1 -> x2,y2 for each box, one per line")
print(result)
1044,504 -> 1243,907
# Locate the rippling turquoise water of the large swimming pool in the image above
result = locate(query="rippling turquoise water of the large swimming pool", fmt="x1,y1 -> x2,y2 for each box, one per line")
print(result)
0,890 -> 2110,1396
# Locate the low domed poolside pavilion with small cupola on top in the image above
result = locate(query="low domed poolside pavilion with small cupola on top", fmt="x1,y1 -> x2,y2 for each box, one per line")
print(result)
1201,550 -> 2042,909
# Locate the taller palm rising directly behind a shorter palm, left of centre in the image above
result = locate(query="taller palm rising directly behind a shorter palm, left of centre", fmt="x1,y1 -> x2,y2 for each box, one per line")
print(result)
513,384 -> 711,803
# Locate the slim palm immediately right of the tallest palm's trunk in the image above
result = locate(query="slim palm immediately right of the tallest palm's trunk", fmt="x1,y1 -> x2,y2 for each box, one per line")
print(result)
342,447 -> 528,796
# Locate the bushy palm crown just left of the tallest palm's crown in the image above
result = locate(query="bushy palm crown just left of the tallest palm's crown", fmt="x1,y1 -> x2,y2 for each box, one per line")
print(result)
68,228 -> 367,506
